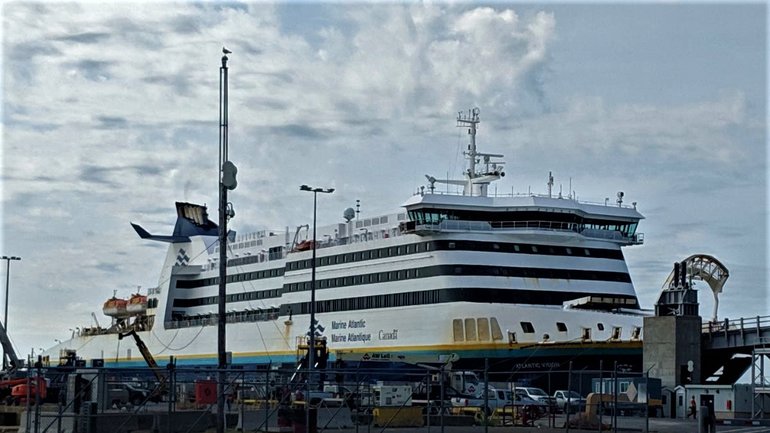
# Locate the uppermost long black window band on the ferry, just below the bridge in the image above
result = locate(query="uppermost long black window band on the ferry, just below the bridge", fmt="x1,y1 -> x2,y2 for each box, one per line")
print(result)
286,241 -> 623,271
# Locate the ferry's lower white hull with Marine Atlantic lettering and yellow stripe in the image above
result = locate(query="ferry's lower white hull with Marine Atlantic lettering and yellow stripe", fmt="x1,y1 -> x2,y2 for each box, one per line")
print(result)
51,302 -> 642,371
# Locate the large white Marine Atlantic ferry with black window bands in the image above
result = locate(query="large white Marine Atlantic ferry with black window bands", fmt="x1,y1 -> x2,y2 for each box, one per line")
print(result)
43,109 -> 645,370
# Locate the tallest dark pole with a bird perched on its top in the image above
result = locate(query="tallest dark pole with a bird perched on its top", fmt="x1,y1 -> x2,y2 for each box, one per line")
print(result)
217,49 -> 228,433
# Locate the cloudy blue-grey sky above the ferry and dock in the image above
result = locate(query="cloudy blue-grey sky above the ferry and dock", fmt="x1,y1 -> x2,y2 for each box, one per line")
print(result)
0,2 -> 769,355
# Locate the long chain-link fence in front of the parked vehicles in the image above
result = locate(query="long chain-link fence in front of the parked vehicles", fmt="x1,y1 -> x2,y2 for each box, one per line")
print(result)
4,365 -> 662,433
